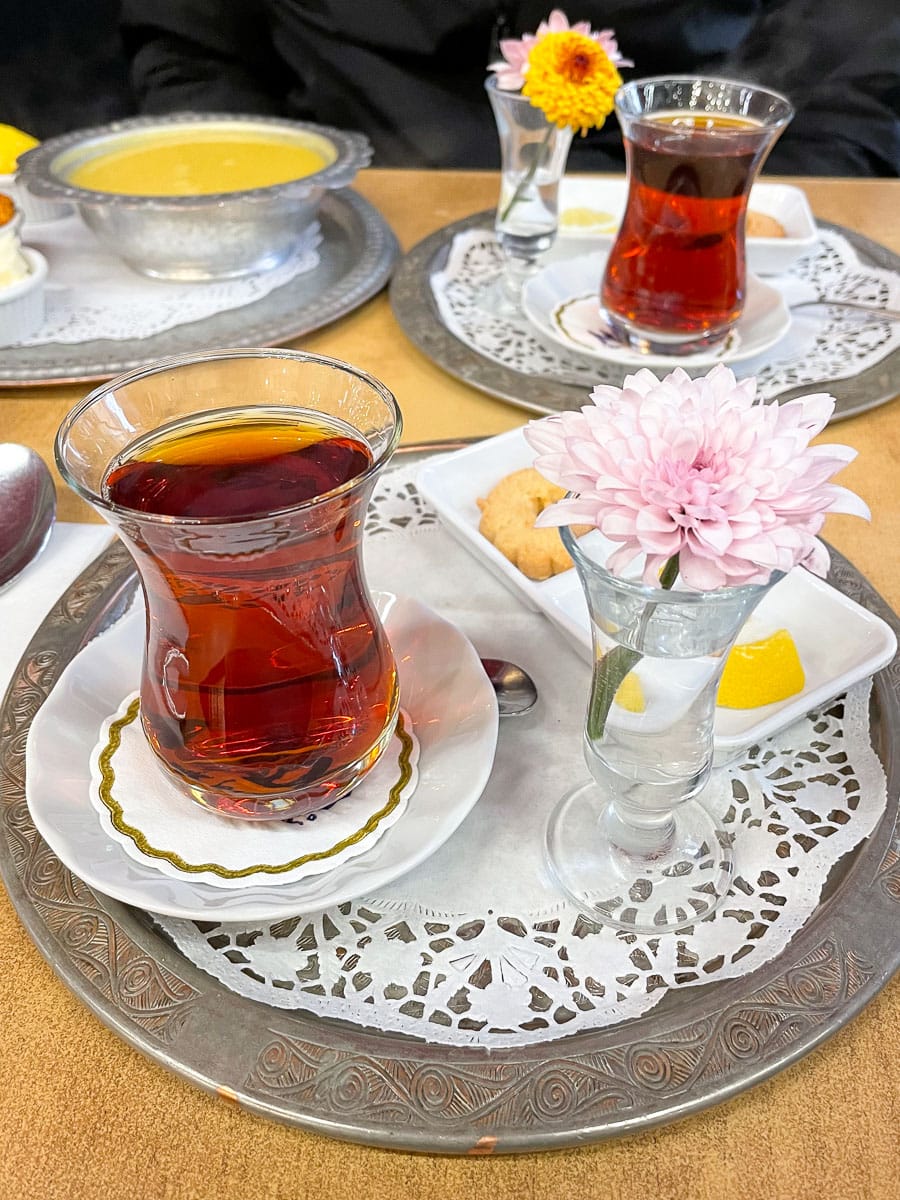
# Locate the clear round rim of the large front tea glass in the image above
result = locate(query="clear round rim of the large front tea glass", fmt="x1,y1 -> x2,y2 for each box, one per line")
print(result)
54,347 -> 403,528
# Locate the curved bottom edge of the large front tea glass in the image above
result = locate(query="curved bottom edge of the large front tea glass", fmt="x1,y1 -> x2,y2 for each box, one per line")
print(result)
154,708 -> 400,821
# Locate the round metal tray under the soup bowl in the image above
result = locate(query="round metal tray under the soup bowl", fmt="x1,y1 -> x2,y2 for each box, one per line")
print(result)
0,188 -> 400,388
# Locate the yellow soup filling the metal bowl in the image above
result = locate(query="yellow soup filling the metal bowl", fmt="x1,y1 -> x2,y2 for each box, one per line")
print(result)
68,132 -> 331,196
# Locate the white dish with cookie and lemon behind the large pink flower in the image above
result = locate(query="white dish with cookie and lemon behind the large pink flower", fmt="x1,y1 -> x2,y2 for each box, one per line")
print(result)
418,428 -> 896,751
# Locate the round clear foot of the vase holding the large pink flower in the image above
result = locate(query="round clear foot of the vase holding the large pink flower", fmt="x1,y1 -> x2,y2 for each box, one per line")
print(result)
545,782 -> 734,934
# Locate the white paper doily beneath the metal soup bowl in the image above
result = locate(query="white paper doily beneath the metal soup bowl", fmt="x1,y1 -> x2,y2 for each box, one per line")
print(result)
17,216 -> 322,346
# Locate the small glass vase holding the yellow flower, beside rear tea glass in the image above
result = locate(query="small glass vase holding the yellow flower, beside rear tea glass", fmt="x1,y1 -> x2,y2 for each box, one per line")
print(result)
485,78 -> 572,314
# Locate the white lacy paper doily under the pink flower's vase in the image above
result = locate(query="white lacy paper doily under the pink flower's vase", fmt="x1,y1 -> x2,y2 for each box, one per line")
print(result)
151,468 -> 886,1048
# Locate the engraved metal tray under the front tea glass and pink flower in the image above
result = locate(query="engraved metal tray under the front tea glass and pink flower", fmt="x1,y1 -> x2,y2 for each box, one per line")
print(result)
0,444 -> 900,1153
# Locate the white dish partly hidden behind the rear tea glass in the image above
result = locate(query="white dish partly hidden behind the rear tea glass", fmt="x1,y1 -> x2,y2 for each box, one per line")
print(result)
557,175 -> 818,275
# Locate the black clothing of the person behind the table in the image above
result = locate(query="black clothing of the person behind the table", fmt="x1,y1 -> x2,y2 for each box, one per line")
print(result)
0,0 -> 900,175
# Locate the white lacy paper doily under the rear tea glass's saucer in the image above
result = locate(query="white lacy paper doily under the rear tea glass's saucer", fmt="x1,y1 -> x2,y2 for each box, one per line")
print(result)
431,229 -> 900,403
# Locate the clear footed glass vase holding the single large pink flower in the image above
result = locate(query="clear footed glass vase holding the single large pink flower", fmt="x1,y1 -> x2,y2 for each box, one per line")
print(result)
546,529 -> 781,934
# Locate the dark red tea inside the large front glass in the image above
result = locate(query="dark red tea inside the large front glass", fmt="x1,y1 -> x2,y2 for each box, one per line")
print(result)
103,408 -> 397,817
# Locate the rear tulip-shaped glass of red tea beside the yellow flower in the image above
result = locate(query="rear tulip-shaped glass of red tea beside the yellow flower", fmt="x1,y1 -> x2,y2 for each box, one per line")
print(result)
600,78 -> 793,355
